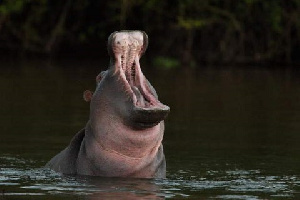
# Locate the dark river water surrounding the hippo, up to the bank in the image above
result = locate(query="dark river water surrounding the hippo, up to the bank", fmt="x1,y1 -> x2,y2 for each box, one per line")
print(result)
0,61 -> 300,200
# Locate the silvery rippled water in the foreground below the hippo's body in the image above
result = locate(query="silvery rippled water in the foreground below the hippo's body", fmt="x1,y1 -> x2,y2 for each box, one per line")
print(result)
0,156 -> 300,200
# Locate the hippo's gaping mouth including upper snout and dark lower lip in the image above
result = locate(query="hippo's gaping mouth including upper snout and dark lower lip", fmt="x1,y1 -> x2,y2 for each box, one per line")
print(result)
108,31 -> 170,128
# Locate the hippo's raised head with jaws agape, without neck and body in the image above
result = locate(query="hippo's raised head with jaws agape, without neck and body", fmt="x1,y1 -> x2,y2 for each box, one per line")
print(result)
90,31 -> 170,129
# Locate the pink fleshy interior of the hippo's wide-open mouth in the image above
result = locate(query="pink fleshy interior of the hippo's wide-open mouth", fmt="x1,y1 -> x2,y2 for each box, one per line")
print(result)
112,32 -> 165,109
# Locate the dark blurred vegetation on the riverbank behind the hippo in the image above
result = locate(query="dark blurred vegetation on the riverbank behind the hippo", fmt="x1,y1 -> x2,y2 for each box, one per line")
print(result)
0,0 -> 300,68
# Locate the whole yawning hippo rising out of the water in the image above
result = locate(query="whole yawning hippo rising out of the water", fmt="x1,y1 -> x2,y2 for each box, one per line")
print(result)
46,31 -> 170,178
